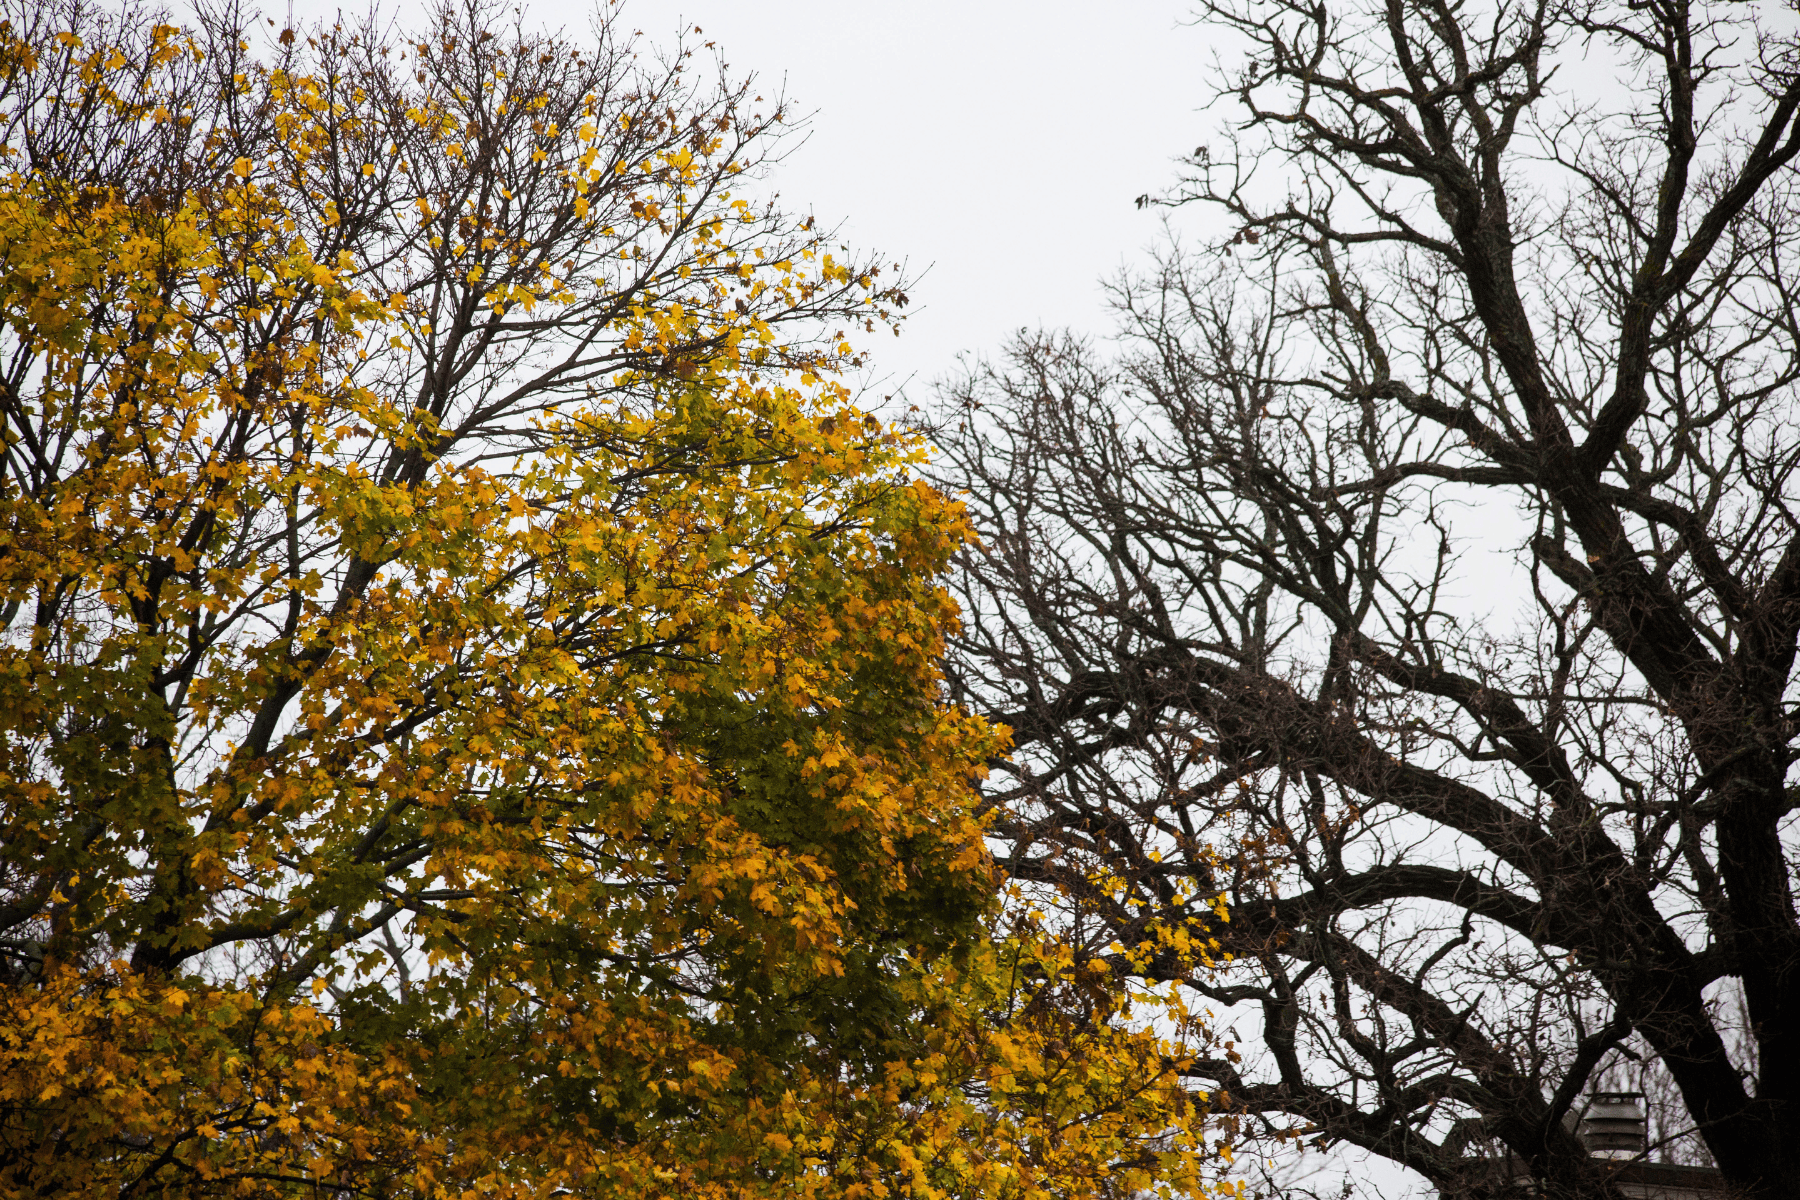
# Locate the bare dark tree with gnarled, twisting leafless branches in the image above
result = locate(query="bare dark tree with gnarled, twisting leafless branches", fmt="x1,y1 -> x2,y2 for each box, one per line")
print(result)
936,0 -> 1800,1196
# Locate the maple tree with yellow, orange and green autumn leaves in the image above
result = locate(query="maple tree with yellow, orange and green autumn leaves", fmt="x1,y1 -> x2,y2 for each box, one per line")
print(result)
0,2 -> 1231,1196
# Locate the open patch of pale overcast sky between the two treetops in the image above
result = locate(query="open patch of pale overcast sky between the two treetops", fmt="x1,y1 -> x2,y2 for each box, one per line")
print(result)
576,0 -> 1213,402
